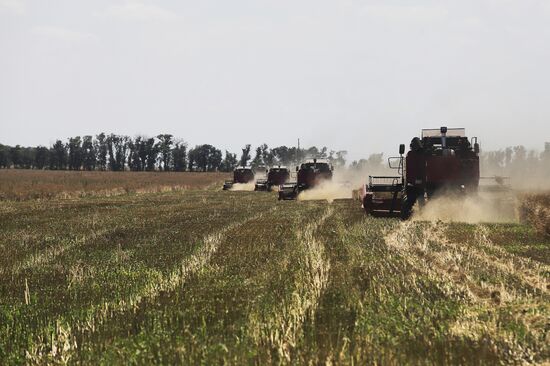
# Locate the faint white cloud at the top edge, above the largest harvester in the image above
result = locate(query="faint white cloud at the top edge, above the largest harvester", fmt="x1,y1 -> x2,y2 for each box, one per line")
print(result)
363,4 -> 449,23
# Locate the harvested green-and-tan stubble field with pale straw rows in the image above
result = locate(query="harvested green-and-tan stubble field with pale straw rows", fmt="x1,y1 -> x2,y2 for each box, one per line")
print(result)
0,172 -> 550,364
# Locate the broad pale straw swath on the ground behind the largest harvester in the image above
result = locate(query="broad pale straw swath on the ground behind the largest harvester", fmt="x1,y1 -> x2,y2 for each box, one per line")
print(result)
385,223 -> 547,360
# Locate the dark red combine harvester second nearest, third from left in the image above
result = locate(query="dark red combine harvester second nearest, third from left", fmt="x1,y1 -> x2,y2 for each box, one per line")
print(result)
279,159 -> 334,200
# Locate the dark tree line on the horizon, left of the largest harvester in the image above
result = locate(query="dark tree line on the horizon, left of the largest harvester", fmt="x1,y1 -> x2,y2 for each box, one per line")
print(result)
0,133 -> 347,172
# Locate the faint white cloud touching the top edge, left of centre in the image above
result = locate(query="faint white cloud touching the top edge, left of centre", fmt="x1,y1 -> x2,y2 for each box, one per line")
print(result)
102,0 -> 178,21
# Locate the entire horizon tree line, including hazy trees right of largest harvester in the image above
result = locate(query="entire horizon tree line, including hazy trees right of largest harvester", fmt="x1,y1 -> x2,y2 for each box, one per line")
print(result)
0,133 -> 550,176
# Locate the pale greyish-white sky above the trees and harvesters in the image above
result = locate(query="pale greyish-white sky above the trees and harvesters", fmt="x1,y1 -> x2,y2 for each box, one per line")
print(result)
0,0 -> 550,159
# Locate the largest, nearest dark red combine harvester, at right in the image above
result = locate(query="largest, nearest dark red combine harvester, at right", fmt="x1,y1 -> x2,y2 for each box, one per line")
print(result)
361,127 -> 480,219
